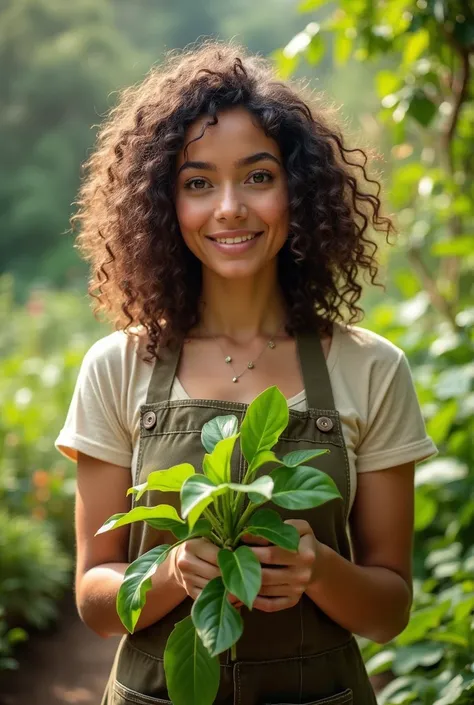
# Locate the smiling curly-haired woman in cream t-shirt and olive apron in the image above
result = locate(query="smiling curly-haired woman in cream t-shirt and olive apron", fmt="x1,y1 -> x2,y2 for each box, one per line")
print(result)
56,42 -> 435,705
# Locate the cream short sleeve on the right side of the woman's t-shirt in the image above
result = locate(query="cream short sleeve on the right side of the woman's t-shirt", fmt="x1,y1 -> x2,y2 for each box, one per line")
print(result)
356,351 -> 437,472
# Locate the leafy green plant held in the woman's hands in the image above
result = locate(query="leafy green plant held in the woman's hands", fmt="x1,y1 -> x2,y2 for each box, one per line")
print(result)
97,387 -> 340,705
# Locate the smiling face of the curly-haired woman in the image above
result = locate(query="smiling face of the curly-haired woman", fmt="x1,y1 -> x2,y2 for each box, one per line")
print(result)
176,108 -> 288,279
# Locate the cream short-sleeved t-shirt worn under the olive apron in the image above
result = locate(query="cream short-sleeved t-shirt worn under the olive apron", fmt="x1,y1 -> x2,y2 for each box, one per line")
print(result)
55,324 -> 437,506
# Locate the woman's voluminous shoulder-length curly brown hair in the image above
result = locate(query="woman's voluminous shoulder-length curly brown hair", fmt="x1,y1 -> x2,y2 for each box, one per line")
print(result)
71,40 -> 394,362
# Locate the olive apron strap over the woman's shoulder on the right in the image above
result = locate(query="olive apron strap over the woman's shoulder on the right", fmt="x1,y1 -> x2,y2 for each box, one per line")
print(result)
296,331 -> 335,410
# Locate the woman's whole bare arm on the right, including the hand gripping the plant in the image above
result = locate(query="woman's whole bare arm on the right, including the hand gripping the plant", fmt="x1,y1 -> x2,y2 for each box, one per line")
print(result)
252,463 -> 414,643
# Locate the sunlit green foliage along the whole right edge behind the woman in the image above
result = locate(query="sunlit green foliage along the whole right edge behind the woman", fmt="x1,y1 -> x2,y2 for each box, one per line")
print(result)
282,0 -> 474,705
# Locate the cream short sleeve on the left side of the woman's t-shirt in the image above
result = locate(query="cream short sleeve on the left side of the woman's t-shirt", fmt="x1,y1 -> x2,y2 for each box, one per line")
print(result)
54,338 -> 132,467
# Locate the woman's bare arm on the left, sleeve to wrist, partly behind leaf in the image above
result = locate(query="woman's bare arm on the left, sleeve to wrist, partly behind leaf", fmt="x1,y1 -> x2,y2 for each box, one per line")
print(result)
76,452 -> 187,637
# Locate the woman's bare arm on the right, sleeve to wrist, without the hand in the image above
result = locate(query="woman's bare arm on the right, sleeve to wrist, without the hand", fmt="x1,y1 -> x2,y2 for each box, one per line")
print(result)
306,463 -> 414,643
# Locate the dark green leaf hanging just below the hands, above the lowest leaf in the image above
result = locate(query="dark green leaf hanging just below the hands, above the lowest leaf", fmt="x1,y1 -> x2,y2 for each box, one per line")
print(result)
191,577 -> 243,656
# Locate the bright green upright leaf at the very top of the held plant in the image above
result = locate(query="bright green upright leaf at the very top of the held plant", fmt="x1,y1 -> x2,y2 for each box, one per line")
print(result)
240,387 -> 289,464
